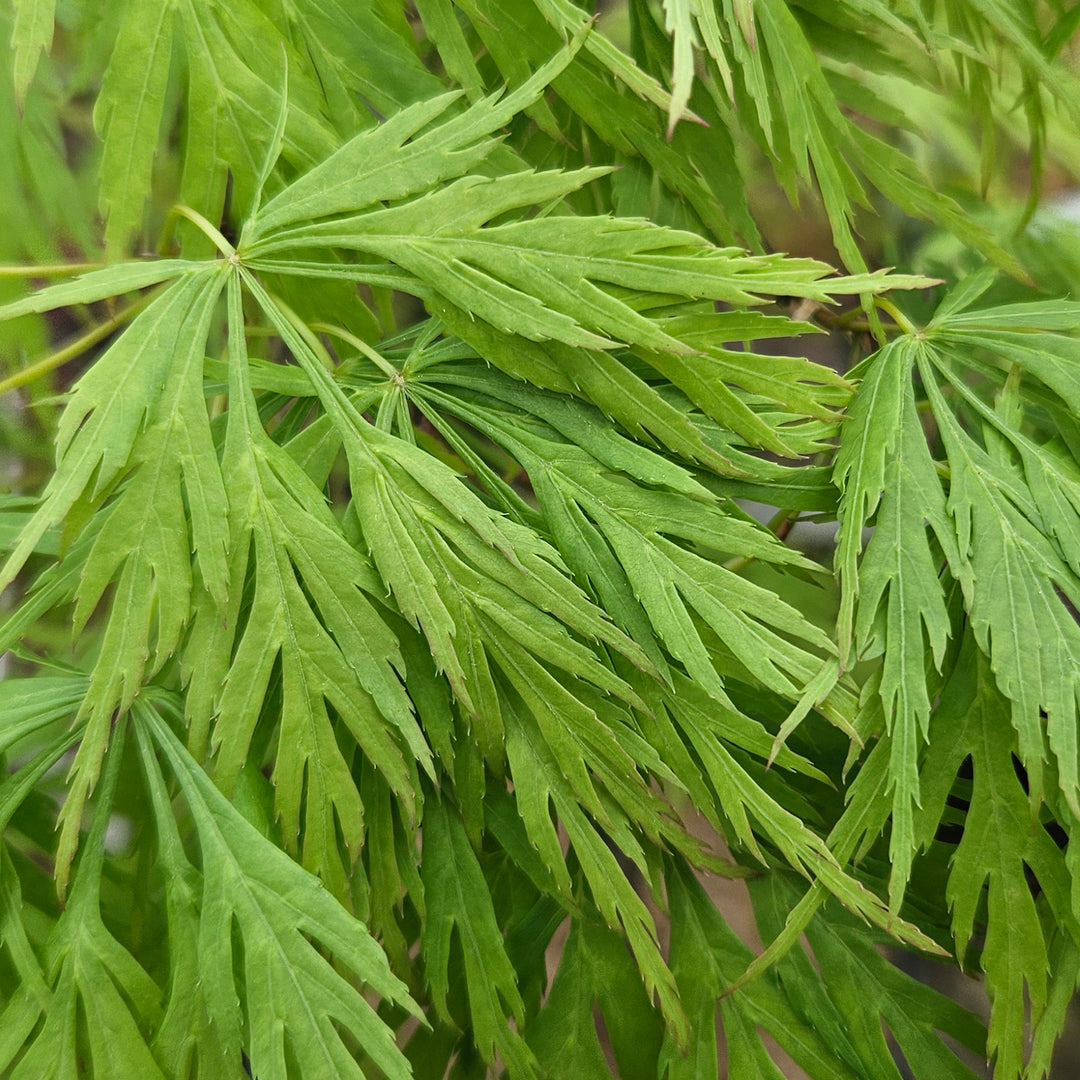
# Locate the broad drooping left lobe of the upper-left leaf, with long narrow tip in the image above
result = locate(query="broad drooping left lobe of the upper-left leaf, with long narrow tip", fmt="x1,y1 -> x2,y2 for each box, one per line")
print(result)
3,268 -> 225,893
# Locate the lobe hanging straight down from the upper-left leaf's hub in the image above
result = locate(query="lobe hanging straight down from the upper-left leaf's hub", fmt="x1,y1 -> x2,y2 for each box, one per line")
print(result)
194,278 -> 430,893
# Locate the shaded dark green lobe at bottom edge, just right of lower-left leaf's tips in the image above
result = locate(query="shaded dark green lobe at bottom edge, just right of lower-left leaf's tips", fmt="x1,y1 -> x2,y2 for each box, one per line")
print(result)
420,799 -> 538,1078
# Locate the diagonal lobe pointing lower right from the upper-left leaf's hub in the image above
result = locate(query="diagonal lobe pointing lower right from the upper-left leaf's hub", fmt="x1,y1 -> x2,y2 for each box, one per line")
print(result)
248,267 -> 648,761
